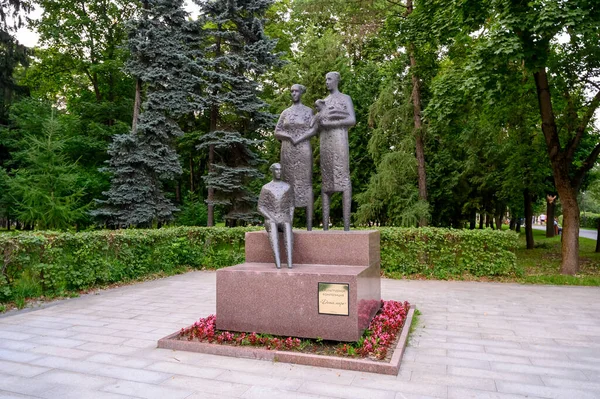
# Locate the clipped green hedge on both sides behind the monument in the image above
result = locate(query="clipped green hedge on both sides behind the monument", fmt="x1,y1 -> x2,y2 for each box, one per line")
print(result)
0,227 -> 517,302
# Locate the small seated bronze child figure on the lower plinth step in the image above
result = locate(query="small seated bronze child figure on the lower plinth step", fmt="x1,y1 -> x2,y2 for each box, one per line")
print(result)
258,163 -> 294,269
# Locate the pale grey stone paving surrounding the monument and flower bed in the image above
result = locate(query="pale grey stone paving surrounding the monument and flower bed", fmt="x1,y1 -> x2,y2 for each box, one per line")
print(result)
0,272 -> 600,399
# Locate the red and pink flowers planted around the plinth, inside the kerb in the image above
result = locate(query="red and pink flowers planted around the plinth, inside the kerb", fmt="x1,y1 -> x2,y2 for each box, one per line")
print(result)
177,300 -> 410,360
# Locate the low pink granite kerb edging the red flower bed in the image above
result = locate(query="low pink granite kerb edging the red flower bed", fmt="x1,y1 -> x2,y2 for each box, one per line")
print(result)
158,306 -> 414,375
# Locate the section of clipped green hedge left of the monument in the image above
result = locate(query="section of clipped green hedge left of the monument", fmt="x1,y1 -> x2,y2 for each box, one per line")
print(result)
0,227 -> 253,301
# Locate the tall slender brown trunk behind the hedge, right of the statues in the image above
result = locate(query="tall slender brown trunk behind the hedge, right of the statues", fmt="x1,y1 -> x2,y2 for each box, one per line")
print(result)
406,0 -> 428,226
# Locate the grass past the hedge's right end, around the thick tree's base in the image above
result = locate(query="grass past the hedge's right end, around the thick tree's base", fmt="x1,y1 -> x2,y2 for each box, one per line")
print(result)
515,230 -> 600,286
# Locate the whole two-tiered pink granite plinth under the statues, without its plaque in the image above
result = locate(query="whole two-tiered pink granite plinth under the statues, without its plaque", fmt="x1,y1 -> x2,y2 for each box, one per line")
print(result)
217,231 -> 381,341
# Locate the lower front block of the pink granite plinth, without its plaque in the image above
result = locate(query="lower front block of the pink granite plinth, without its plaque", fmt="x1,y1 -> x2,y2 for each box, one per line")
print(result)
217,263 -> 381,342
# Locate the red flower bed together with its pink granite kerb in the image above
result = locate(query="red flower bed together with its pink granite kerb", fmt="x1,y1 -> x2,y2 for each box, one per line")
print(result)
158,301 -> 414,375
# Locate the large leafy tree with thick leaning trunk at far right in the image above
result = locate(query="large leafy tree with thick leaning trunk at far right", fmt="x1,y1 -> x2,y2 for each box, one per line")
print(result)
425,0 -> 600,274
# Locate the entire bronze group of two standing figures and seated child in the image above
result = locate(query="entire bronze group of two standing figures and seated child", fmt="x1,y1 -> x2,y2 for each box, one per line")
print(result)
258,72 -> 356,268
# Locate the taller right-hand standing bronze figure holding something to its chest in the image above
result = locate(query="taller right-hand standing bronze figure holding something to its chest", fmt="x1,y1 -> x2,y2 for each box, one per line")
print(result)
314,72 -> 356,231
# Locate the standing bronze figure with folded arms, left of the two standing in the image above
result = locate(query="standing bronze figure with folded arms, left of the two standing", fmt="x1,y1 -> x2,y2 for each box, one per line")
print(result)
275,84 -> 318,231
